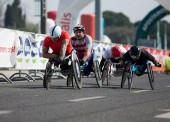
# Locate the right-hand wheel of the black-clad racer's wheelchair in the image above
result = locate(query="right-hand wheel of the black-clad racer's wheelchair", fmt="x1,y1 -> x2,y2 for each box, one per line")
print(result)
147,63 -> 154,90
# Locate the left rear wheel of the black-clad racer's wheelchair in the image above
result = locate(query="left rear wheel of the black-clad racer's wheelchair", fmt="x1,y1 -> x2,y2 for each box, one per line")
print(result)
121,62 -> 131,88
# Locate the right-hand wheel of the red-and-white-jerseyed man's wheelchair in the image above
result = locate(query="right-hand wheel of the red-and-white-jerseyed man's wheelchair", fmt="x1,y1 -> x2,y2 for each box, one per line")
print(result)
93,60 -> 102,88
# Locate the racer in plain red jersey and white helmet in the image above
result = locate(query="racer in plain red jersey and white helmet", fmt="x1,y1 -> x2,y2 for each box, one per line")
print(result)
42,25 -> 72,70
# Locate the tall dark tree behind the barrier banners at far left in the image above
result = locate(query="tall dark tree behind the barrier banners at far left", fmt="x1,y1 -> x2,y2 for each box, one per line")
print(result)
4,0 -> 26,29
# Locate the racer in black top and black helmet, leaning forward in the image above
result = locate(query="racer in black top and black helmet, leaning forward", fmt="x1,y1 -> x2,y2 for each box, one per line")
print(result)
120,46 -> 161,76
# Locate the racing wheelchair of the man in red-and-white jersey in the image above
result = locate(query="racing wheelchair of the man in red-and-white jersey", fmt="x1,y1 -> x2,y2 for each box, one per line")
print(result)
81,50 -> 102,88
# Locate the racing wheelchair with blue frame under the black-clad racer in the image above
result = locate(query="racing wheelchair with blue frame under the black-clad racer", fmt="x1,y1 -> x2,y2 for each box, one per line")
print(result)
121,61 -> 161,90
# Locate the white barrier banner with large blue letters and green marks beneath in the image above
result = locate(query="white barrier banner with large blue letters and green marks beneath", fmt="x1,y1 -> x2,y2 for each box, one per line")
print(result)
15,31 -> 48,70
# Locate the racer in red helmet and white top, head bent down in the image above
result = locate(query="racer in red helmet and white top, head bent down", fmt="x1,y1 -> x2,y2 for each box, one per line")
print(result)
100,45 -> 127,71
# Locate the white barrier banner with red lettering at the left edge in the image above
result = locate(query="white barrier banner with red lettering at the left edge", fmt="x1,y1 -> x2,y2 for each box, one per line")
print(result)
0,28 -> 18,68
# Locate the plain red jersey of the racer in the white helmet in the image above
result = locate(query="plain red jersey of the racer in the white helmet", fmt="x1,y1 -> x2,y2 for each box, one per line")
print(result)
43,31 -> 72,55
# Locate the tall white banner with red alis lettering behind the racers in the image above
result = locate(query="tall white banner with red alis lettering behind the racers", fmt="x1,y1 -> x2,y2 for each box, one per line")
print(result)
56,0 -> 93,35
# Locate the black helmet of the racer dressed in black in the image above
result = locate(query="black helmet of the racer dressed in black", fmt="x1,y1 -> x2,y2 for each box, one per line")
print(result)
129,46 -> 141,58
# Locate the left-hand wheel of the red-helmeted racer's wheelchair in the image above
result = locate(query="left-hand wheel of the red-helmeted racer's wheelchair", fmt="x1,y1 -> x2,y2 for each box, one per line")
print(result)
102,60 -> 109,84
